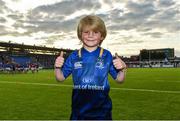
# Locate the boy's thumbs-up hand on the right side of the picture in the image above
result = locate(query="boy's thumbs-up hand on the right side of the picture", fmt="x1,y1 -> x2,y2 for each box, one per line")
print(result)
113,53 -> 126,70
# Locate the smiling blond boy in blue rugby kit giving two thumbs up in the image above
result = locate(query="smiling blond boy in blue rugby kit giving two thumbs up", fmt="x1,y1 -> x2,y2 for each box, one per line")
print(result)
55,15 -> 126,120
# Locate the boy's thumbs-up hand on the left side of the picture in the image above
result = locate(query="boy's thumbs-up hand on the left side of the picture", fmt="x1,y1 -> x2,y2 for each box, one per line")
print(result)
54,51 -> 64,68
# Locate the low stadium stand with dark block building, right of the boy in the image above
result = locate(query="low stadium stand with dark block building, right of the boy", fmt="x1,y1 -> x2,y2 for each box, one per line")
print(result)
126,48 -> 180,68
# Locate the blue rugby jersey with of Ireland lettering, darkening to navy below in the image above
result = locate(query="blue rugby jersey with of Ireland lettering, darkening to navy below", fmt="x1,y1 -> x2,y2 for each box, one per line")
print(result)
62,47 -> 117,120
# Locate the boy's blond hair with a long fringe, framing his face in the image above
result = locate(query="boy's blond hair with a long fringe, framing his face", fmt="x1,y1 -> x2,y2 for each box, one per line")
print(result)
77,15 -> 107,45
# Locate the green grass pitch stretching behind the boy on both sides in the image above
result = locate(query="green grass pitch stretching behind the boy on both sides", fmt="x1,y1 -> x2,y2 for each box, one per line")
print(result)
0,68 -> 180,120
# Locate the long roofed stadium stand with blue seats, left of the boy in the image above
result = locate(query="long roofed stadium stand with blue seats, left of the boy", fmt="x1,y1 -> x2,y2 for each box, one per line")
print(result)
0,42 -> 73,73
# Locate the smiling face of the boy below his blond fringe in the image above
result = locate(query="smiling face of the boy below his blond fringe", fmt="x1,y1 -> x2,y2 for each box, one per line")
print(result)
82,27 -> 103,47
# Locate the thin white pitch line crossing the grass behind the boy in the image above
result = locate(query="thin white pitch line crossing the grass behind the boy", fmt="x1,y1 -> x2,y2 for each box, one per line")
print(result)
0,81 -> 180,94
